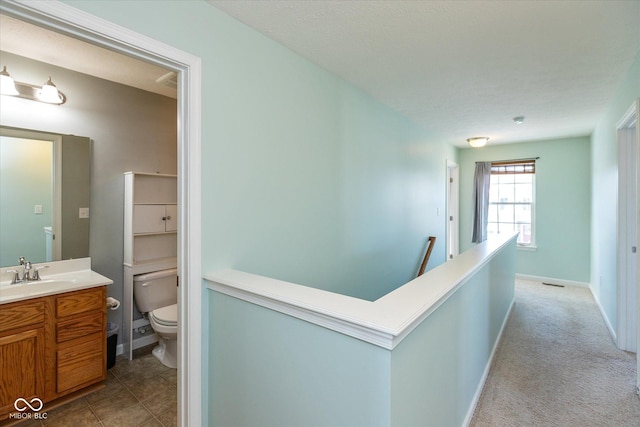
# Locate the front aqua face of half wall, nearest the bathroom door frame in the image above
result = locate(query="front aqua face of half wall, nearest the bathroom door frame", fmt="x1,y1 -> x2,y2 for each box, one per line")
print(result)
210,292 -> 391,427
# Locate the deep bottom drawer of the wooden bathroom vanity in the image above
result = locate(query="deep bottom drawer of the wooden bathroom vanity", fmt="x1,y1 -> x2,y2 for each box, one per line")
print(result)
56,333 -> 107,393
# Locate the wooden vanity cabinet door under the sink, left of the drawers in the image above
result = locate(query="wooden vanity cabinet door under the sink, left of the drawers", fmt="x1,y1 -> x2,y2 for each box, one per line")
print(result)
0,327 -> 45,419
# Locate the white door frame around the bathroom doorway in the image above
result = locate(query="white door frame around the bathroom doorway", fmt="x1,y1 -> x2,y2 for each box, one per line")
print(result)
0,0 -> 203,426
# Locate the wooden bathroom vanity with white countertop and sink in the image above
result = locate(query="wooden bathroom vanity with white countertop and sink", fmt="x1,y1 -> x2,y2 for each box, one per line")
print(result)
0,260 -> 113,421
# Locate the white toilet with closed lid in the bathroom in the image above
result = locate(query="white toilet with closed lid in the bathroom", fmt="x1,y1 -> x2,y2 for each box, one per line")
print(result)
133,268 -> 178,368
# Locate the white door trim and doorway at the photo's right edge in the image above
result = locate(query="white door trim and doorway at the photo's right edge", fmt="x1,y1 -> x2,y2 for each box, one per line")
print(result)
616,100 -> 640,362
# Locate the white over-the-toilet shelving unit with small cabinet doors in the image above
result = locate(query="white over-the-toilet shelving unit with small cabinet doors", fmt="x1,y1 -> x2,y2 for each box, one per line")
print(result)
122,172 -> 178,360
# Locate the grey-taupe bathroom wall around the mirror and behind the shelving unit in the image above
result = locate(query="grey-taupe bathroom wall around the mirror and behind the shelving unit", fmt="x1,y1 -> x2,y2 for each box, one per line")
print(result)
0,52 -> 177,339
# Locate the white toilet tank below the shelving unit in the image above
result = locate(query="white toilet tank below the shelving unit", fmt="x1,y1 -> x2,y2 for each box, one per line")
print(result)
133,268 -> 178,313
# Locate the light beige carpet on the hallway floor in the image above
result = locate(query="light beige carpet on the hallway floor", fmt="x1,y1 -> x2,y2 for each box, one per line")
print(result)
471,280 -> 640,427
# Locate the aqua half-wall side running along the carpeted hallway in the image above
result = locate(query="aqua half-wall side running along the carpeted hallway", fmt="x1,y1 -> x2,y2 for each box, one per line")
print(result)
390,240 -> 516,427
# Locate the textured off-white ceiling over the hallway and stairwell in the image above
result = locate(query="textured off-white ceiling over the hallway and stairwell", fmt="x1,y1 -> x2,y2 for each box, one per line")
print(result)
209,0 -> 640,146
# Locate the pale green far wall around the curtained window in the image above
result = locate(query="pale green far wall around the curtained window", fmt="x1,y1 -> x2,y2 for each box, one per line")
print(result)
459,137 -> 591,283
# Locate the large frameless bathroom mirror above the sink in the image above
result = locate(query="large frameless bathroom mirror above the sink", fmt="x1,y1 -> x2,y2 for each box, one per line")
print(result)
0,126 -> 91,267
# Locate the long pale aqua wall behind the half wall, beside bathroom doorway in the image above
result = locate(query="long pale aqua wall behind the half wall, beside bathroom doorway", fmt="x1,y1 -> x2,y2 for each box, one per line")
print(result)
63,1 -> 456,299
